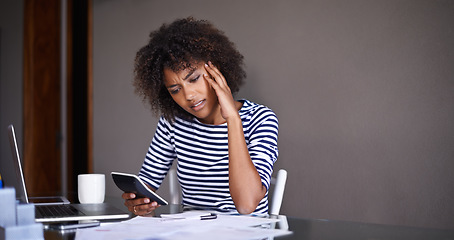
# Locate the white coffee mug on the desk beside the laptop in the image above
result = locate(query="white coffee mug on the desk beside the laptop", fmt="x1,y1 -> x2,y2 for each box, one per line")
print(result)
77,174 -> 106,203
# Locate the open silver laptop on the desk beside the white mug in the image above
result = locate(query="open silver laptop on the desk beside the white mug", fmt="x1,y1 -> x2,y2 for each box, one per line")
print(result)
8,125 -> 129,223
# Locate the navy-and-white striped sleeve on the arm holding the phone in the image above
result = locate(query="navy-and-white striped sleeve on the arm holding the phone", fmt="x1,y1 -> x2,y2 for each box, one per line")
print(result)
139,117 -> 177,190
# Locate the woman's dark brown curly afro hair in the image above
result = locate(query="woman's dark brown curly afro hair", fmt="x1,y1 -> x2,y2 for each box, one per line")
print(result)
134,17 -> 246,121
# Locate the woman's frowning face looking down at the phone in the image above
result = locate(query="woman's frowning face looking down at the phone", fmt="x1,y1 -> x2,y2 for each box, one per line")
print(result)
164,63 -> 225,124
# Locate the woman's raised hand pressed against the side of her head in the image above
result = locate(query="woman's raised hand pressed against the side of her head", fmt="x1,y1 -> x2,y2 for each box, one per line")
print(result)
203,61 -> 239,121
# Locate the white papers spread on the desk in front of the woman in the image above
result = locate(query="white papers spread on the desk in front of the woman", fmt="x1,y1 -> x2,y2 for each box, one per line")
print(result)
76,211 -> 291,240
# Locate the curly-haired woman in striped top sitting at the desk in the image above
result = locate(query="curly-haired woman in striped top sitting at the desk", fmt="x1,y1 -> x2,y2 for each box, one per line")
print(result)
122,18 -> 278,215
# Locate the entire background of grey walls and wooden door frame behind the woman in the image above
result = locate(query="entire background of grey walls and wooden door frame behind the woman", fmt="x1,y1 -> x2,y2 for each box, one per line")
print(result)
0,0 -> 454,229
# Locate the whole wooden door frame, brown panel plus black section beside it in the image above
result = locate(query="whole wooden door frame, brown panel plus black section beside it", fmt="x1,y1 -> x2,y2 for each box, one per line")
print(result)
23,0 -> 93,196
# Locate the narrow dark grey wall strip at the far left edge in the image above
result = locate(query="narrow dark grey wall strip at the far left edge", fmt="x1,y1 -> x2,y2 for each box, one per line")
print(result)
0,0 -> 24,193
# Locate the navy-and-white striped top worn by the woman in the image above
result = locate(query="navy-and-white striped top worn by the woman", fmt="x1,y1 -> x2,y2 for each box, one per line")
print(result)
139,100 -> 278,214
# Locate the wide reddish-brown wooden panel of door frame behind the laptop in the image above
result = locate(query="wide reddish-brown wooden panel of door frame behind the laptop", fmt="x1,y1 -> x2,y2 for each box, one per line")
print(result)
23,0 -> 61,196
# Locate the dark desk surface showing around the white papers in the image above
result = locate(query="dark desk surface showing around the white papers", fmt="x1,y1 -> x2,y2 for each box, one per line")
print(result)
44,205 -> 454,240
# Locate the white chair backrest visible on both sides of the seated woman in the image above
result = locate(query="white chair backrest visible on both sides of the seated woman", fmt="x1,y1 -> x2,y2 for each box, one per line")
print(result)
168,168 -> 287,215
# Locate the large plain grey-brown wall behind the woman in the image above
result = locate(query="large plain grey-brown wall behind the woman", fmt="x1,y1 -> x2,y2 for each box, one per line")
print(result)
86,0 -> 454,229
